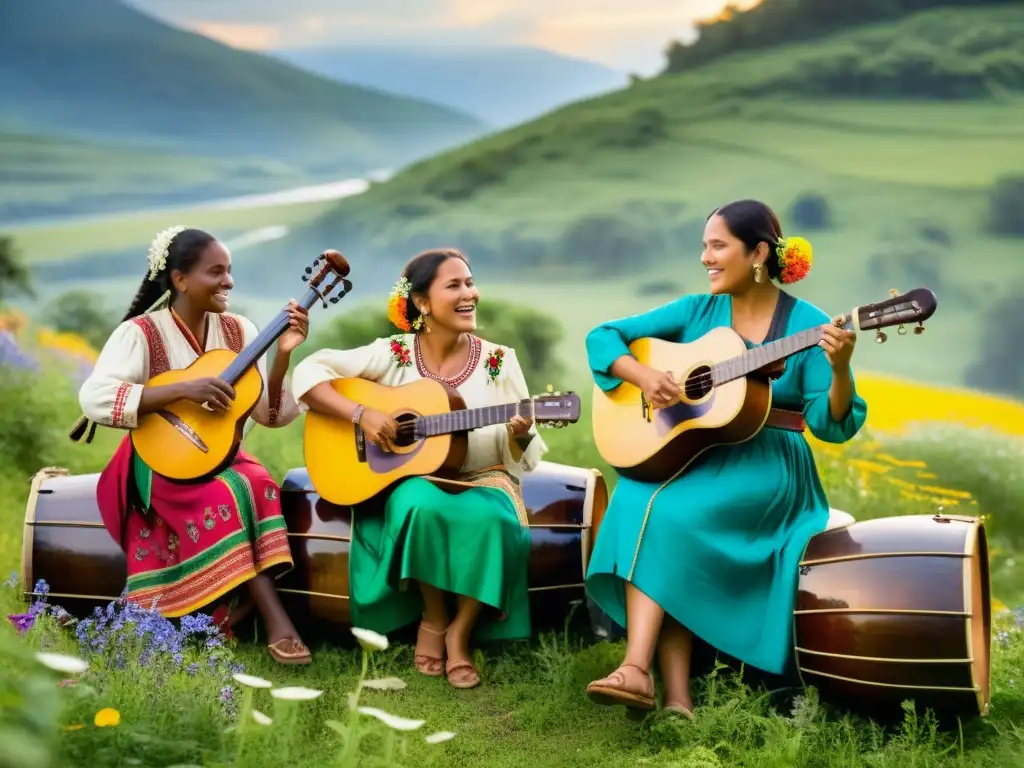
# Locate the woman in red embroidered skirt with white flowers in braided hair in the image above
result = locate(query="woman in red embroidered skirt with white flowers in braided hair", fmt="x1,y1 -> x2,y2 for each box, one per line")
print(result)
71,226 -> 311,664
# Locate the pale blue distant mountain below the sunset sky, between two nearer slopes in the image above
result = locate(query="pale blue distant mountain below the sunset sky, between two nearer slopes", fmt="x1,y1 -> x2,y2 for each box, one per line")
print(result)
276,45 -> 629,127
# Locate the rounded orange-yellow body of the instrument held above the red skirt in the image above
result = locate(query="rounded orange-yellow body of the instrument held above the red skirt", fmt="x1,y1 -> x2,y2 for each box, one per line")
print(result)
131,349 -> 263,481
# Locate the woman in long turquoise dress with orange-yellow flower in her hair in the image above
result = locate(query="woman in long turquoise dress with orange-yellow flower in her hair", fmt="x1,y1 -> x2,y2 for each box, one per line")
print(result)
587,200 -> 867,719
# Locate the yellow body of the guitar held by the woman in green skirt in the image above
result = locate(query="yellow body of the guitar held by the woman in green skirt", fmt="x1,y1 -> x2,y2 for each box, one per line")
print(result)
303,379 -> 469,506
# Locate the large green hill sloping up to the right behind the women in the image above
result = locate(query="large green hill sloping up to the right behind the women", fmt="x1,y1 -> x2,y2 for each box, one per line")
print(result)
235,0 -> 1024,391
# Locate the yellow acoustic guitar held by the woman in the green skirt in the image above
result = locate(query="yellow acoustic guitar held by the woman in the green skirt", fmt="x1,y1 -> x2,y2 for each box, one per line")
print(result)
303,379 -> 580,506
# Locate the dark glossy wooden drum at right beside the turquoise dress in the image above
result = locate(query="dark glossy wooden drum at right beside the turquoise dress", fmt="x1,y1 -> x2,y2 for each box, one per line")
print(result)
794,515 -> 991,719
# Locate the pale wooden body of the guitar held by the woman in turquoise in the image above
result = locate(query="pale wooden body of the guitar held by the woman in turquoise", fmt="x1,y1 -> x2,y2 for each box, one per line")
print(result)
592,327 -> 779,482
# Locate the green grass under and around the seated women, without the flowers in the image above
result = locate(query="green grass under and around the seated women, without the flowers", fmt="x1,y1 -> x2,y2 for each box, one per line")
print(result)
0,348 -> 1024,768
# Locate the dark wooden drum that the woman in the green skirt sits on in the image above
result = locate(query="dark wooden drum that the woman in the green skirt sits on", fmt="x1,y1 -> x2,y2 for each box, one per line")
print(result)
278,462 -> 608,627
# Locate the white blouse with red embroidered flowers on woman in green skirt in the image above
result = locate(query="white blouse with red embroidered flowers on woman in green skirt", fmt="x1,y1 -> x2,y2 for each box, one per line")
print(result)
292,334 -> 548,478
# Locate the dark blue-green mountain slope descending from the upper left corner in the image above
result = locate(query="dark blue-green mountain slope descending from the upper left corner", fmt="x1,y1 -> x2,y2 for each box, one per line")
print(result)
0,0 -> 485,173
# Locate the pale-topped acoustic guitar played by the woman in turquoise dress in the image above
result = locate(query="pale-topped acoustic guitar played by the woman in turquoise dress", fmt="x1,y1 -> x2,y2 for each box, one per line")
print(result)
593,288 -> 937,482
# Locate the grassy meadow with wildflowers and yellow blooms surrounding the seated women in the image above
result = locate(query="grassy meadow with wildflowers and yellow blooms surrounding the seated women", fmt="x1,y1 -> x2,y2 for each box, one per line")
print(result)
0,327 -> 1024,768
